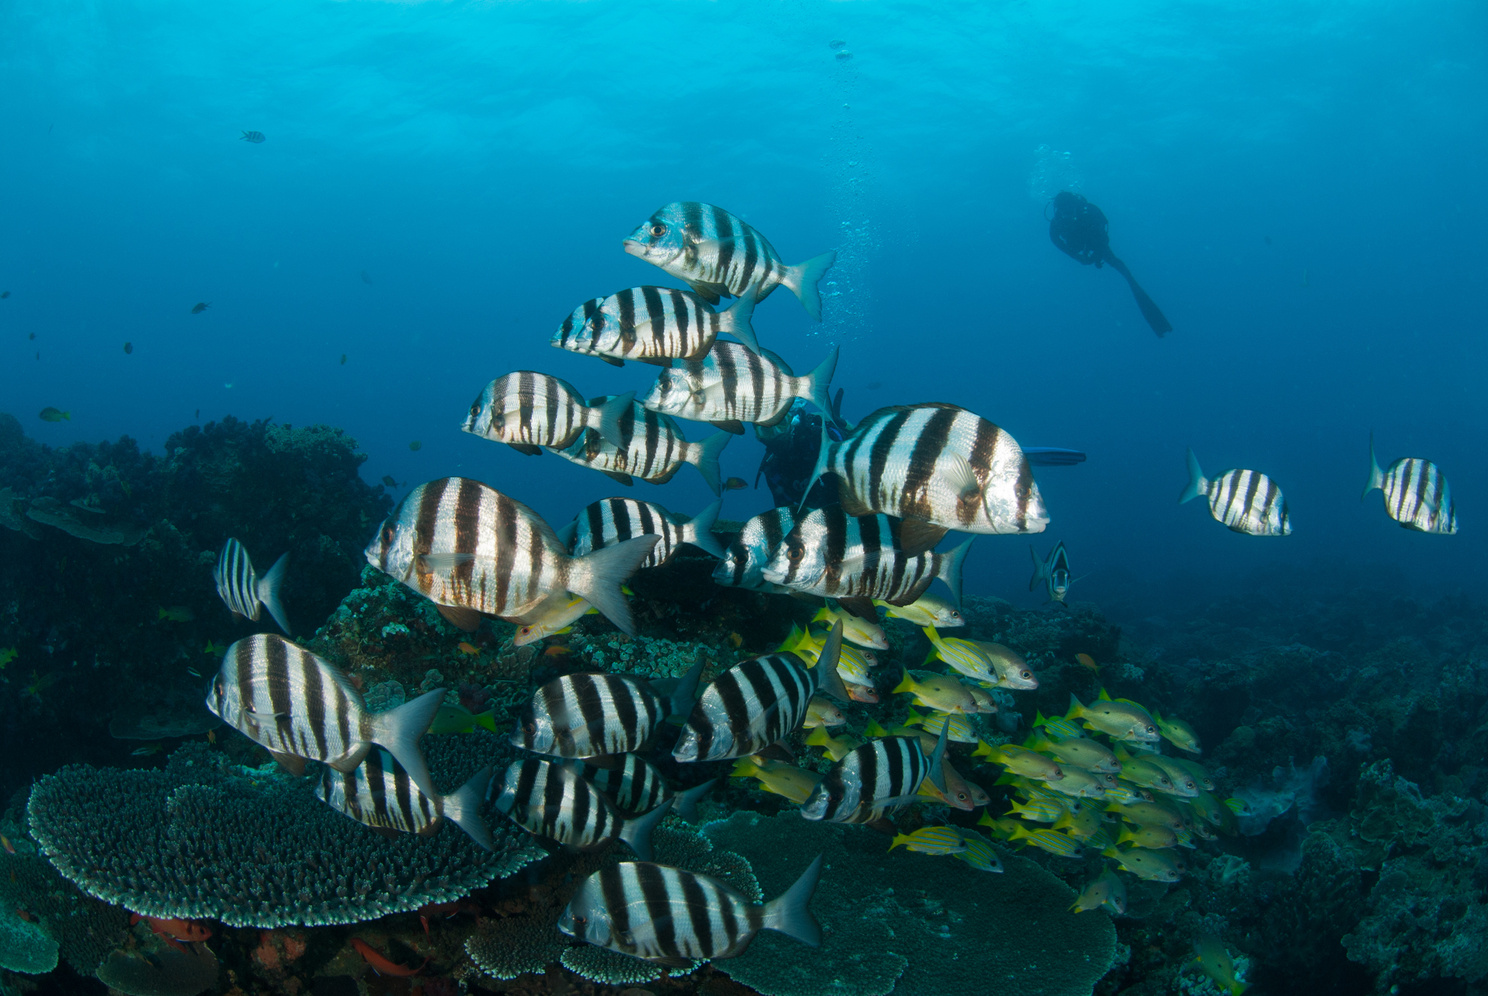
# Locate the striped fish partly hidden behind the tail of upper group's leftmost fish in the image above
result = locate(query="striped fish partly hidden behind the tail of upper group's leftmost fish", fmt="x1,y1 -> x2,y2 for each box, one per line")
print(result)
554,399 -> 729,494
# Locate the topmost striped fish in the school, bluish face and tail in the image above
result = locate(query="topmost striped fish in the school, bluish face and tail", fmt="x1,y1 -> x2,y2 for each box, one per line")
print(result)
625,201 -> 836,322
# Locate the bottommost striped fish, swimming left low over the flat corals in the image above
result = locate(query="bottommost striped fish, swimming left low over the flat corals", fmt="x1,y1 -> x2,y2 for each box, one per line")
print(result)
558,856 -> 821,965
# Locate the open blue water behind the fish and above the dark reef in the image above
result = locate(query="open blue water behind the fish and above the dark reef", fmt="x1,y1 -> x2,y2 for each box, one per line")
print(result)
0,0 -> 1488,610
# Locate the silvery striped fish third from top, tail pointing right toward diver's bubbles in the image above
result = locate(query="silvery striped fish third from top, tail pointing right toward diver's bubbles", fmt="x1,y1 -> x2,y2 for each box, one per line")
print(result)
641,342 -> 838,433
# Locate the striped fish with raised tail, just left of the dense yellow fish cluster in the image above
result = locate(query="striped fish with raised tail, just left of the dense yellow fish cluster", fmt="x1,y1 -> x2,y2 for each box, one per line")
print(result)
801,730 -> 945,823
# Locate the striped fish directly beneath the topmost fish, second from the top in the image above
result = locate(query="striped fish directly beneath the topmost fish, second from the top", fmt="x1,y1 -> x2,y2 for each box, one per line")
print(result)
551,287 -> 759,366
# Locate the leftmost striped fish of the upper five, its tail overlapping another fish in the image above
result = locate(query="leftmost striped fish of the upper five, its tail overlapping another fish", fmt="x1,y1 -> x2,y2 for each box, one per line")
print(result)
460,371 -> 634,457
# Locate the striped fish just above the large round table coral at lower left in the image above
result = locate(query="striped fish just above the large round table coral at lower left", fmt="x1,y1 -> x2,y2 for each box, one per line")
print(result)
315,750 -> 496,850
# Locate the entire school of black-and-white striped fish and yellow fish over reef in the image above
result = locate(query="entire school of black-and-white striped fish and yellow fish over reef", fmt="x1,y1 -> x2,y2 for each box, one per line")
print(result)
194,198 -> 1457,965
